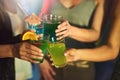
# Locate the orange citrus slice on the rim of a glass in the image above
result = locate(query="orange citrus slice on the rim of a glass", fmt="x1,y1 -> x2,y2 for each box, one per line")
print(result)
22,31 -> 38,40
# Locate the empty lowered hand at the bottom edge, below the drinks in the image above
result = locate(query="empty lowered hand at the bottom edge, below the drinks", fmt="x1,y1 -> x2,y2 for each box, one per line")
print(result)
39,59 -> 56,80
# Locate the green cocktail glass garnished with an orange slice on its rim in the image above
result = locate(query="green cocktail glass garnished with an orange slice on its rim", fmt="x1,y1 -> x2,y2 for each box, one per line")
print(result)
21,28 -> 49,63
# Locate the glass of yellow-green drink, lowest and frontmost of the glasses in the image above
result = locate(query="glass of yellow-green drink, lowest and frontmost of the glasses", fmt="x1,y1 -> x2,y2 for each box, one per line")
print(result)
48,42 -> 66,68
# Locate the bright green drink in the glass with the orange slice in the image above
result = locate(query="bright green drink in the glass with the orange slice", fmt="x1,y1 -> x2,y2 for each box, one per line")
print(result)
31,40 -> 48,63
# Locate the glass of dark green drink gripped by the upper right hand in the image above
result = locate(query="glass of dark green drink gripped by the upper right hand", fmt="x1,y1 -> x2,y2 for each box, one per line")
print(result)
43,14 -> 63,41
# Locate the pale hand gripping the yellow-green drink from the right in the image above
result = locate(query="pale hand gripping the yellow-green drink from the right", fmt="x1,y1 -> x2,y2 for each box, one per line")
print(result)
64,49 -> 78,62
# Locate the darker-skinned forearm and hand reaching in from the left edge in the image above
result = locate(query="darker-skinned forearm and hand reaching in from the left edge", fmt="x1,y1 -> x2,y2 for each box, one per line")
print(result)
0,42 -> 43,63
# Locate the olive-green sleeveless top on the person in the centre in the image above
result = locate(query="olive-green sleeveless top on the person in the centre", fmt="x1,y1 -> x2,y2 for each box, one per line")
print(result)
50,0 -> 96,48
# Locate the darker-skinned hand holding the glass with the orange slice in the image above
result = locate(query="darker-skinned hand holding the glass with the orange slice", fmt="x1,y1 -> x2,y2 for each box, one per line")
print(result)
12,42 -> 44,63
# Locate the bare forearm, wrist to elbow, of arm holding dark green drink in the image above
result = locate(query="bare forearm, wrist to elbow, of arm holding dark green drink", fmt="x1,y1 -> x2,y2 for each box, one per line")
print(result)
69,27 -> 99,42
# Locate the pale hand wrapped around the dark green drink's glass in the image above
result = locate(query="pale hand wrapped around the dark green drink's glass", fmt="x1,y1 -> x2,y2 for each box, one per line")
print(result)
55,21 -> 72,40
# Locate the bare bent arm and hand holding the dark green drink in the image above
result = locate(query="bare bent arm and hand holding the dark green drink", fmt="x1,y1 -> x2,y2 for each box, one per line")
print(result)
56,0 -> 104,42
